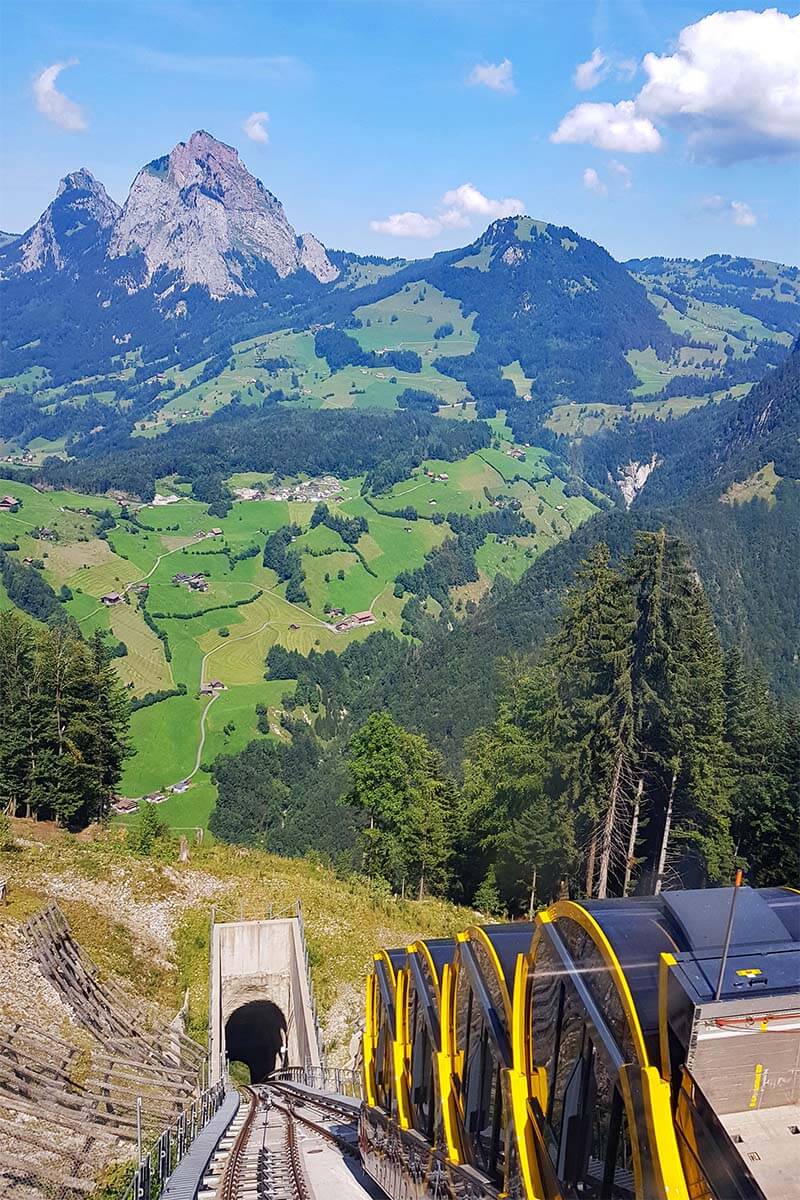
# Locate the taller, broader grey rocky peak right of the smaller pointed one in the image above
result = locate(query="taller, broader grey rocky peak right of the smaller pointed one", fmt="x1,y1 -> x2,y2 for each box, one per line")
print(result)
109,130 -> 338,299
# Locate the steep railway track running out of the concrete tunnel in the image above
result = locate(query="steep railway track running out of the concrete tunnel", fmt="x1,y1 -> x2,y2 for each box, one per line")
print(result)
206,1085 -> 371,1200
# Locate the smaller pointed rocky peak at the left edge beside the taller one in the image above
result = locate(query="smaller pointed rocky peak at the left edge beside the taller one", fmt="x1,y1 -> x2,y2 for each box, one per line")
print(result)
6,167 -> 122,276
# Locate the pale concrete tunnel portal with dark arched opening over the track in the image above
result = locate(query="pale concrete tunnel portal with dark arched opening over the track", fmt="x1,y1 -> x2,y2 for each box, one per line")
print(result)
210,916 -> 321,1084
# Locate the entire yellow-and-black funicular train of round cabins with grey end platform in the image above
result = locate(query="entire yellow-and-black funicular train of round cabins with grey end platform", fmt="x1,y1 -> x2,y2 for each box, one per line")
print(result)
361,887 -> 800,1200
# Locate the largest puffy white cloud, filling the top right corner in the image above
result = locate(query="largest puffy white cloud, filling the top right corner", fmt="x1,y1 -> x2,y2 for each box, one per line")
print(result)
636,8 -> 800,162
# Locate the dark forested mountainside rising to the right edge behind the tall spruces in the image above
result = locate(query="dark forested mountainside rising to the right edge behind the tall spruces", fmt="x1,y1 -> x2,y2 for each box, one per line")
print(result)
340,352 -> 800,764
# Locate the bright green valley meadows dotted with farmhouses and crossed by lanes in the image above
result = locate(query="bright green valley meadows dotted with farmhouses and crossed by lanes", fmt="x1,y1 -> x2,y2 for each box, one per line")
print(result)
0,432 -> 594,828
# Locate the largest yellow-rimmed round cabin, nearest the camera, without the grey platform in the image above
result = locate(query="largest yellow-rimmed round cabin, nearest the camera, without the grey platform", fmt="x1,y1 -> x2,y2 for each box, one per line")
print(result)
515,900 -> 686,1200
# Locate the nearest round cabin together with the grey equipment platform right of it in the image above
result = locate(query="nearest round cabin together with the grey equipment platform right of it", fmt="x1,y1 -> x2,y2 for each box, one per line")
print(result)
513,888 -> 800,1200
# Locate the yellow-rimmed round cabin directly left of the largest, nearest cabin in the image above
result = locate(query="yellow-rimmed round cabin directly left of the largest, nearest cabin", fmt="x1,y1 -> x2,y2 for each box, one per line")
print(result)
445,922 -> 533,1188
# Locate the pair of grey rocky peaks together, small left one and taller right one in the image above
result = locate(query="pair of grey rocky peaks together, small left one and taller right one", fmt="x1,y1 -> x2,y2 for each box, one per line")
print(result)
0,131 -> 339,300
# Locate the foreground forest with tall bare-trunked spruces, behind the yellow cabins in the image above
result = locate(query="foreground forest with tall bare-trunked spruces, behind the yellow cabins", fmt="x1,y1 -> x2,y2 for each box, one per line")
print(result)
212,529 -> 800,912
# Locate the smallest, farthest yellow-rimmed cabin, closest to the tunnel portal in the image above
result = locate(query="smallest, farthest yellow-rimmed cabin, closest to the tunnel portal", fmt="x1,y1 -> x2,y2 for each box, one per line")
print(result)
363,949 -> 405,1117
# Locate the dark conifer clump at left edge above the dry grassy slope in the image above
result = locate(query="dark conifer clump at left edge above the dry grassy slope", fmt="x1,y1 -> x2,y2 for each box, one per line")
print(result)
0,611 -> 130,828
